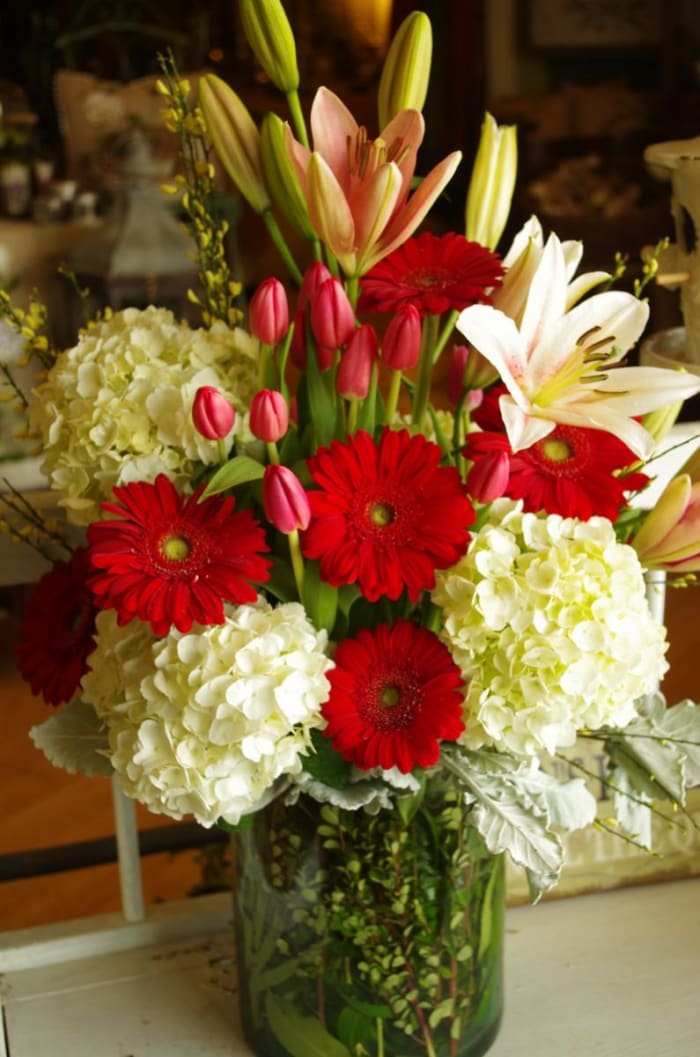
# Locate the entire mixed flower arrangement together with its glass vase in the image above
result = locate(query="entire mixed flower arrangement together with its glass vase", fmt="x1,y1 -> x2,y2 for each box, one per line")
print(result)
2,0 -> 700,1055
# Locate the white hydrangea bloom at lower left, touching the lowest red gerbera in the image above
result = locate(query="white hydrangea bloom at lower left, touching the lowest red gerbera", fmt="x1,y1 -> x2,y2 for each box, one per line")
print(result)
82,599 -> 333,826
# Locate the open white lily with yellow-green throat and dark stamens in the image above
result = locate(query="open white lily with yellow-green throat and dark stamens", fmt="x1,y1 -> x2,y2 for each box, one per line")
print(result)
457,235 -> 700,458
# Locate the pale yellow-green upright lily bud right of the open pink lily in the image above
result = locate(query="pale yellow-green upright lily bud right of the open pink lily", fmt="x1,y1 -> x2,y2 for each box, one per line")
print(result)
464,113 -> 518,249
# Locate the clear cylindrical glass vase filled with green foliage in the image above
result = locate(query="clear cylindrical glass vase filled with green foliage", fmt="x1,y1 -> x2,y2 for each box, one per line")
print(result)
234,779 -> 504,1057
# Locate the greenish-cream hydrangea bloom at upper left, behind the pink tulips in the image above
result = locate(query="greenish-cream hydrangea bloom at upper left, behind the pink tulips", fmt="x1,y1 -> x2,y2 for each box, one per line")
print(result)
31,305 -> 258,524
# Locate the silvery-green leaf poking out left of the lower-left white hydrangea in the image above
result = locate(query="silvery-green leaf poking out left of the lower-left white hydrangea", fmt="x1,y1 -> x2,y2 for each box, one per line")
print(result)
30,698 -> 114,778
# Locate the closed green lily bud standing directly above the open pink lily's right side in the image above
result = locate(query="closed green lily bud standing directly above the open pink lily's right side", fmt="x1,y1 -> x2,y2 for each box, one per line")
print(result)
377,11 -> 432,129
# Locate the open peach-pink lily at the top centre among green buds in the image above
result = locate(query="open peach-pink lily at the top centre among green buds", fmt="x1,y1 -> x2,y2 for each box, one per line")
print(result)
285,88 -> 462,277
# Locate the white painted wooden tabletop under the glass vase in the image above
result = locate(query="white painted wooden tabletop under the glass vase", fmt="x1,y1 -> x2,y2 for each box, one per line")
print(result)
0,879 -> 700,1057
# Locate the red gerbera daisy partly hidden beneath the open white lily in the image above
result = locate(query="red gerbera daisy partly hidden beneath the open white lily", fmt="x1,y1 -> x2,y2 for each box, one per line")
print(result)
464,426 -> 649,521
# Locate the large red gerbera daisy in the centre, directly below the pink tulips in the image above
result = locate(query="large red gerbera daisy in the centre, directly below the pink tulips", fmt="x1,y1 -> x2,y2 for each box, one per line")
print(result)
301,427 -> 475,601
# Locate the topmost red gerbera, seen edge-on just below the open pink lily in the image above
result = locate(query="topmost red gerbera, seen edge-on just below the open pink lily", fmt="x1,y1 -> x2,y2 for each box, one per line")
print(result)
360,231 -> 503,315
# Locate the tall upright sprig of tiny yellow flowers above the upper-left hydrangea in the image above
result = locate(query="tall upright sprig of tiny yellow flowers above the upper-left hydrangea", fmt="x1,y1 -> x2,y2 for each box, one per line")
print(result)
158,54 -> 243,327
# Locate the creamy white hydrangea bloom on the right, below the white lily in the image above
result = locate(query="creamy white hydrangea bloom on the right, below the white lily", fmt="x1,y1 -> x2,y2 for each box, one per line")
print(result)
432,499 -> 668,755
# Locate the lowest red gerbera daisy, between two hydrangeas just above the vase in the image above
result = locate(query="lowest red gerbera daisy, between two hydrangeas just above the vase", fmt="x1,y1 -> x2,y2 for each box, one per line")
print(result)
323,620 -> 464,774
